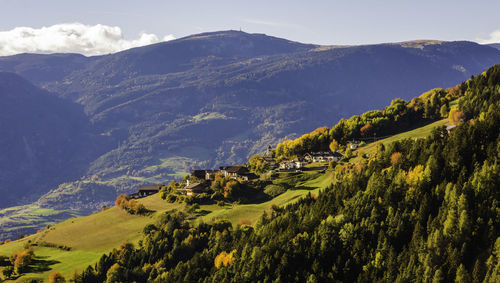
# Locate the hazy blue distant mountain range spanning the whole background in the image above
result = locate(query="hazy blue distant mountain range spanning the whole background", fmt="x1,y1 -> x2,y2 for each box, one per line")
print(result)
0,31 -> 500,240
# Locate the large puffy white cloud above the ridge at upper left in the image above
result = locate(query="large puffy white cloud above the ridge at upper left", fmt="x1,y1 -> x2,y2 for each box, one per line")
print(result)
0,23 -> 174,56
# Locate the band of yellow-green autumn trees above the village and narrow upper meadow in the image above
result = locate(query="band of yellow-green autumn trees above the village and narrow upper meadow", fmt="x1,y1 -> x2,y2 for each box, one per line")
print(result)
274,85 -> 464,160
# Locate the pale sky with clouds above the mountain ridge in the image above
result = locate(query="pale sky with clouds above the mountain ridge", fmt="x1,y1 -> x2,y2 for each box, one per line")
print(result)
0,0 -> 500,55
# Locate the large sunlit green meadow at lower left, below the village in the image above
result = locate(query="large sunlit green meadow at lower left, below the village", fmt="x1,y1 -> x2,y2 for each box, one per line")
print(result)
0,195 -> 181,281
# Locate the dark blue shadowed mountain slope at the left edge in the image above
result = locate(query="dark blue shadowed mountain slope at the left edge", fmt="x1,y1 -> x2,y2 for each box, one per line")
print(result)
0,72 -> 107,206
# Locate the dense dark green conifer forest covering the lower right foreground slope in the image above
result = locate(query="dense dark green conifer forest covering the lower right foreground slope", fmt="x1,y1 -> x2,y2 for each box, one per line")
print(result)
69,65 -> 500,282
